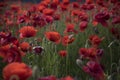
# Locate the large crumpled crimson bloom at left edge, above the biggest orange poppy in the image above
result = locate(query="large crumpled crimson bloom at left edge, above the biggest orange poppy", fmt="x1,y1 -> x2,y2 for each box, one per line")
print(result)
0,44 -> 25,63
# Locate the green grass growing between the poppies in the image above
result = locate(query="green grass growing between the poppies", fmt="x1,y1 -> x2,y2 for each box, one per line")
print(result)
20,23 -> 120,80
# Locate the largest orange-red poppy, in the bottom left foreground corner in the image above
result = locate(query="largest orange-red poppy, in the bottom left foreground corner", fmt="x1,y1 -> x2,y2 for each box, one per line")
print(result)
3,62 -> 32,80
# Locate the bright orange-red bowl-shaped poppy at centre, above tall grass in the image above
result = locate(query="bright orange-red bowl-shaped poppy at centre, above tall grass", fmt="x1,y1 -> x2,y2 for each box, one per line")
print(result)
45,31 -> 61,44
